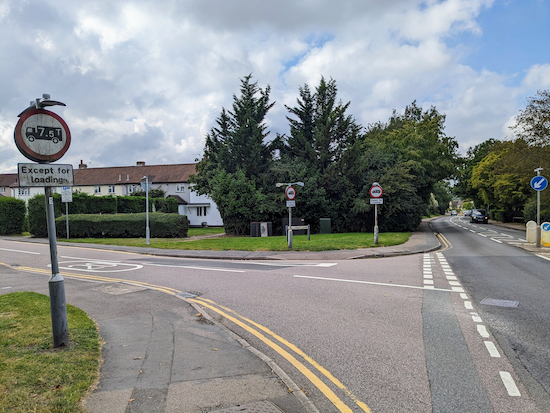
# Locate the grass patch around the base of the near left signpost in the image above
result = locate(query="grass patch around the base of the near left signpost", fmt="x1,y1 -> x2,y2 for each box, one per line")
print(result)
0,292 -> 101,413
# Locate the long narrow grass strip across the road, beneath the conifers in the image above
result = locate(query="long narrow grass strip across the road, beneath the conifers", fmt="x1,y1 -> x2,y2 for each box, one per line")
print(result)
60,232 -> 411,251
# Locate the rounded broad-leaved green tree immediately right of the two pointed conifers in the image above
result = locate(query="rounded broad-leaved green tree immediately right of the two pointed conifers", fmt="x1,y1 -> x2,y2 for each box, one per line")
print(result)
356,102 -> 458,231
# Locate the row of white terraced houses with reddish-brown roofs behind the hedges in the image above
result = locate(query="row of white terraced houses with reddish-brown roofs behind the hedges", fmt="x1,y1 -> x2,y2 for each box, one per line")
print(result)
0,161 -> 223,226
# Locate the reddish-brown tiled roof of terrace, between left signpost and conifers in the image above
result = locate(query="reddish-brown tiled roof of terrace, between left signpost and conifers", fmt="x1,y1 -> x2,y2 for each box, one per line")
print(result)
74,163 -> 196,186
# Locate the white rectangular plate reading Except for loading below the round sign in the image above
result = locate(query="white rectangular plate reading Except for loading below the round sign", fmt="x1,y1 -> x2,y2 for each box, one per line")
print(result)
17,163 -> 74,187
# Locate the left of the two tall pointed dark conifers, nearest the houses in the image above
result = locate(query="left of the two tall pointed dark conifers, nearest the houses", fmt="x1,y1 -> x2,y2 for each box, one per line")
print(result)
193,75 -> 275,235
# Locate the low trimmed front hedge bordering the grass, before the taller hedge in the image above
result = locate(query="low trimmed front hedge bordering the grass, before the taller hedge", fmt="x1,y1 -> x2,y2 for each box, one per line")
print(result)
55,212 -> 189,238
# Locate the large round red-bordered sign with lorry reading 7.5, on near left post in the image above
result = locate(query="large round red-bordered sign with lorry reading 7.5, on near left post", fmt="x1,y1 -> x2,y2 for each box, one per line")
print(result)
14,109 -> 71,162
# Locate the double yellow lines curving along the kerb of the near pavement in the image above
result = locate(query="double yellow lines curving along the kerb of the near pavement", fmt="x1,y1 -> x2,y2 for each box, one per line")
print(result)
0,262 -> 371,413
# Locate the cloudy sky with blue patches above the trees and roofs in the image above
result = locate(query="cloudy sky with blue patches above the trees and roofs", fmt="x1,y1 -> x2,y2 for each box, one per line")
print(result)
0,0 -> 550,173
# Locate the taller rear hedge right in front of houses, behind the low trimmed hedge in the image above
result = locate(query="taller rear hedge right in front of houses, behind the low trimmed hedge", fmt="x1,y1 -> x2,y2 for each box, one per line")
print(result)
28,192 -> 178,238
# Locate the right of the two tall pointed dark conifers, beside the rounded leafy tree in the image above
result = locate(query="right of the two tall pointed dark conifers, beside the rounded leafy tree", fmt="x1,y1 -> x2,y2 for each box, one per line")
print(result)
276,78 -> 362,230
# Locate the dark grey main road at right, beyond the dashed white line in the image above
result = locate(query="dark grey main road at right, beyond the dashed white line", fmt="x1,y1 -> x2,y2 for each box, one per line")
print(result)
433,217 -> 550,411
